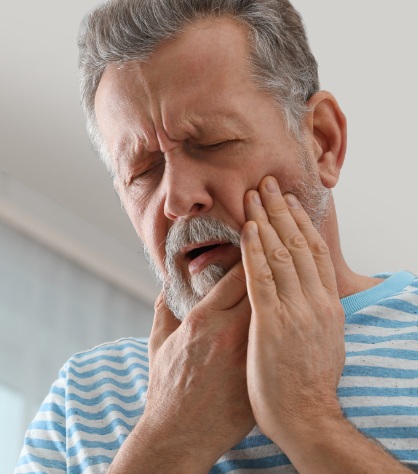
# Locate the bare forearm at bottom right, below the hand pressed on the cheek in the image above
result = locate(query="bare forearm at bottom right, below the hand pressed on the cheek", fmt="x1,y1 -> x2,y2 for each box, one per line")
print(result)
276,415 -> 412,474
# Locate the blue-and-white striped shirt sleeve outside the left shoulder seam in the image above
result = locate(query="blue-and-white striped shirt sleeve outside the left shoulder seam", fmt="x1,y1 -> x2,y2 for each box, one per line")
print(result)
15,365 -> 67,474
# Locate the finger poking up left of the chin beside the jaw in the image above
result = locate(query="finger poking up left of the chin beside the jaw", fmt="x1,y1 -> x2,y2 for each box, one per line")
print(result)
148,293 -> 180,357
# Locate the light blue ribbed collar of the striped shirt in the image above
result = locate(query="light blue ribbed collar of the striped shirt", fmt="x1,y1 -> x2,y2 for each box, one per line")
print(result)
341,271 -> 416,316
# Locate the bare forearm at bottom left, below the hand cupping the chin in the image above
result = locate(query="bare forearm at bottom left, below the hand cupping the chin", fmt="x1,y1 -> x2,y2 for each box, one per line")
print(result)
108,420 -> 213,474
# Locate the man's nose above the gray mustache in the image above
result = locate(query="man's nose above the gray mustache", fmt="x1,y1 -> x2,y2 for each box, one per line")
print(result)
164,152 -> 213,220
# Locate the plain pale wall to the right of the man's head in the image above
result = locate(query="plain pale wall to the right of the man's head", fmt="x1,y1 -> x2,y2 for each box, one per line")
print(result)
293,0 -> 418,274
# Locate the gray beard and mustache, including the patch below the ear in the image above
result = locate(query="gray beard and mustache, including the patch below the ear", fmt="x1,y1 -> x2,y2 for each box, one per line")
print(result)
144,150 -> 331,321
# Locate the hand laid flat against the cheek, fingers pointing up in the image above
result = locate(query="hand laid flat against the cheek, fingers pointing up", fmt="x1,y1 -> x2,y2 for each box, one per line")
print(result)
241,177 -> 345,457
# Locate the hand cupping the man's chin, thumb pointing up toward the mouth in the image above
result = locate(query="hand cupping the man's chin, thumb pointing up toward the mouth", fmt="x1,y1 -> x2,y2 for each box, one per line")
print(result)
141,262 -> 255,472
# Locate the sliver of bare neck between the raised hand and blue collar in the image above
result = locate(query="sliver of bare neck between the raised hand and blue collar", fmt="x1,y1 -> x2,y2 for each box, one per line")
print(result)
320,197 -> 383,298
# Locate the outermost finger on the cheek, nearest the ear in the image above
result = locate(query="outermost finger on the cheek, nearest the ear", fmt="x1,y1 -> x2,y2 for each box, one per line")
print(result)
284,193 -> 337,294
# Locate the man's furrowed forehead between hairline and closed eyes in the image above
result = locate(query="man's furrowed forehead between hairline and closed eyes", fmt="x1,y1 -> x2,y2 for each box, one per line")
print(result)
95,18 -> 290,168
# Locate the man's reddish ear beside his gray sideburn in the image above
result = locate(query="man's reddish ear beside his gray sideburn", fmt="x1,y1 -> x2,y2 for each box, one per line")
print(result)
305,91 -> 347,188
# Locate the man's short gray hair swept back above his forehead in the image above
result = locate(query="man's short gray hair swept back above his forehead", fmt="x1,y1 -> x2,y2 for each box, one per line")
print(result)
78,0 -> 319,171
